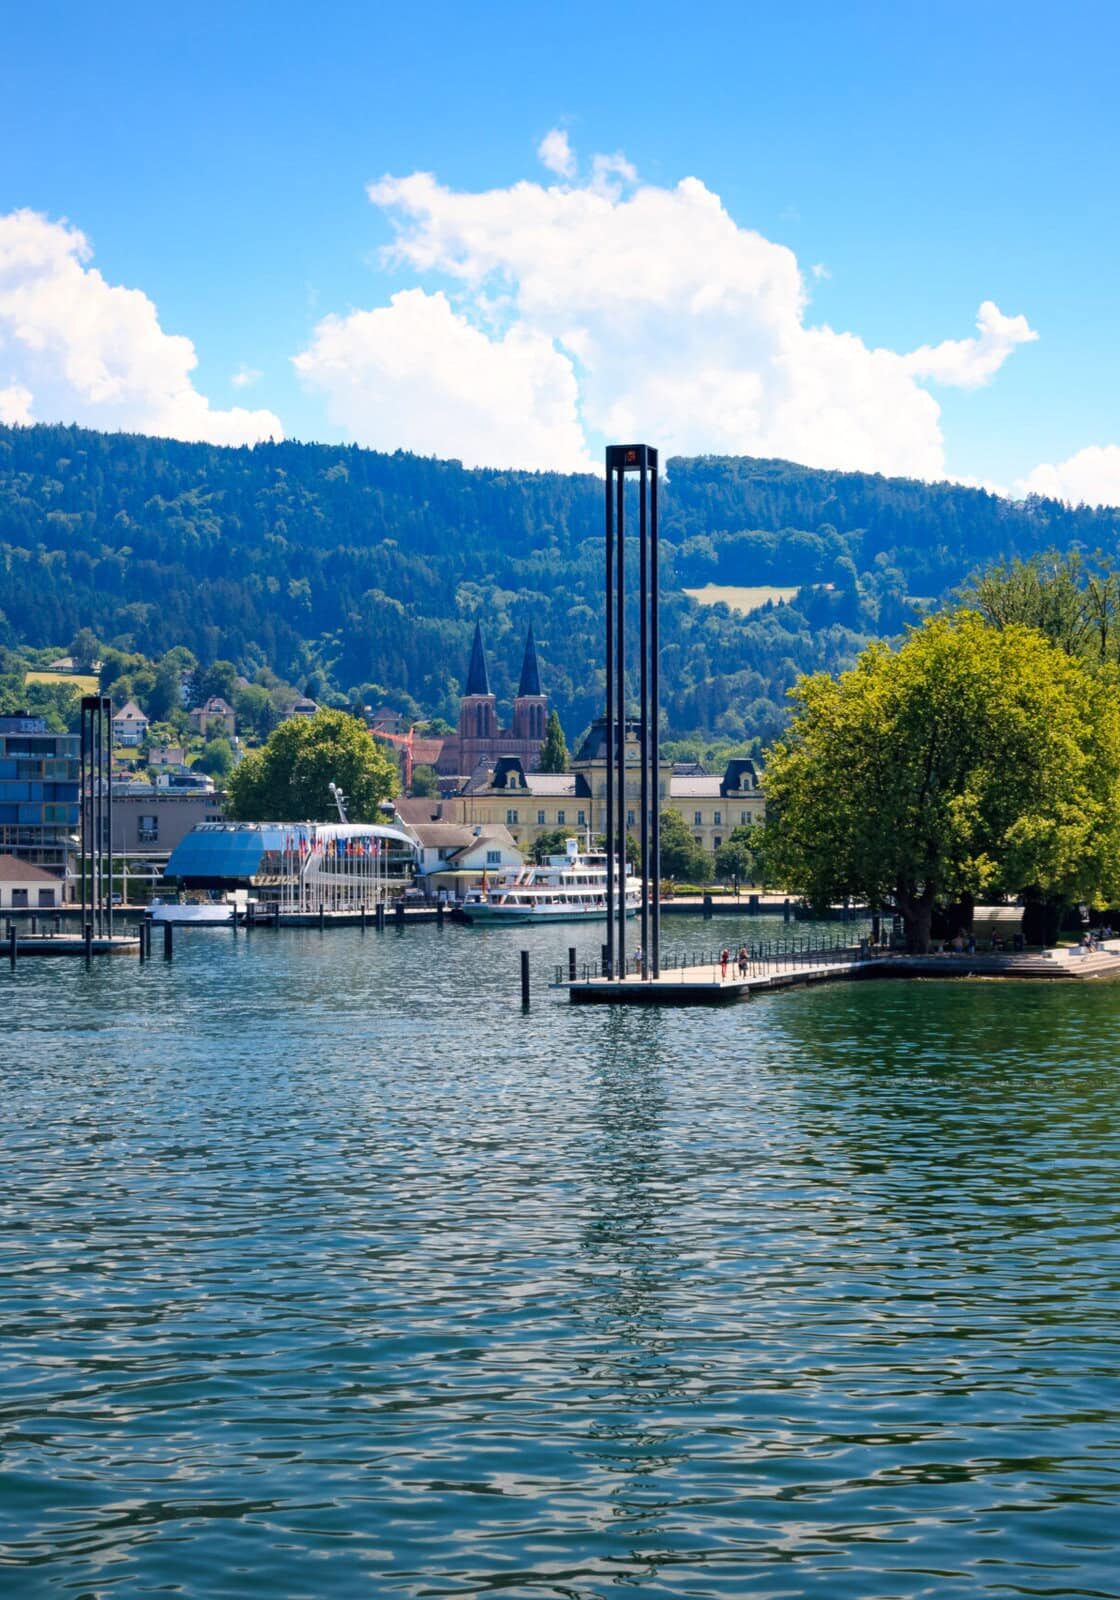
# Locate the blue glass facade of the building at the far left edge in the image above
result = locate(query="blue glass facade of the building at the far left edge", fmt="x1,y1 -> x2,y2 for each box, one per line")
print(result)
0,715 -> 78,878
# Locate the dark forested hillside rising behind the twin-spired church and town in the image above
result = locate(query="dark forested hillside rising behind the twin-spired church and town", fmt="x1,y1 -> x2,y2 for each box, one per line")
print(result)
0,426 -> 1120,738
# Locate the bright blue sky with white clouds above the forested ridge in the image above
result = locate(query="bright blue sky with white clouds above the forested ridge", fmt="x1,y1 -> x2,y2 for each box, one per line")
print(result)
0,3 -> 1120,501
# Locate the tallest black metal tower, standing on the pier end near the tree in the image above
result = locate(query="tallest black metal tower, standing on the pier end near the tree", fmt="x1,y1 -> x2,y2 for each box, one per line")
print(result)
605,445 -> 661,978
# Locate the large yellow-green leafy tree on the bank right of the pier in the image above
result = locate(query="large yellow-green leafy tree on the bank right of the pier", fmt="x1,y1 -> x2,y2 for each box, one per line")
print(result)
765,611 -> 1120,950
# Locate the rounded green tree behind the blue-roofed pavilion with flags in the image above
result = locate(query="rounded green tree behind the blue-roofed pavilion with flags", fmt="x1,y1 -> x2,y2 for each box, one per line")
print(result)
227,710 -> 397,822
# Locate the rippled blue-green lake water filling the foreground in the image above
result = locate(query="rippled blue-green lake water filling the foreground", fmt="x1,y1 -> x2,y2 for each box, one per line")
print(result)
0,923 -> 1120,1600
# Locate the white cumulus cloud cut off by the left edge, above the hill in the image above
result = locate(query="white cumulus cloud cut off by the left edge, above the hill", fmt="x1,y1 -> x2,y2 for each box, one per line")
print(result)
0,211 -> 283,445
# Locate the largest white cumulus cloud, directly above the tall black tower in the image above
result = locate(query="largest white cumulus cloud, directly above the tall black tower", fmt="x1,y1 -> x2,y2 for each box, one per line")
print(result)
296,142 -> 1035,478
